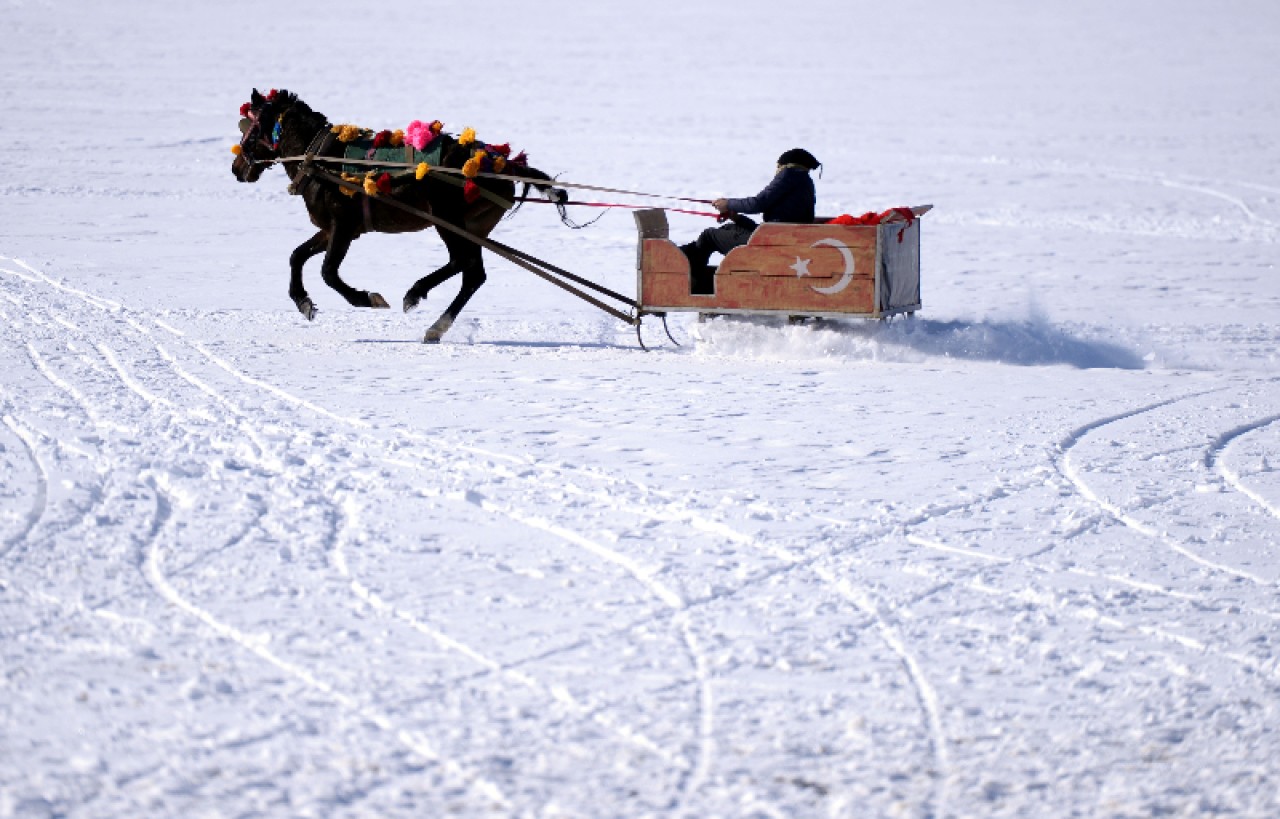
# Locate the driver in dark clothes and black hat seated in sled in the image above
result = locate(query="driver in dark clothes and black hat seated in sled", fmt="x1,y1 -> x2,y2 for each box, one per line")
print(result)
680,148 -> 822,294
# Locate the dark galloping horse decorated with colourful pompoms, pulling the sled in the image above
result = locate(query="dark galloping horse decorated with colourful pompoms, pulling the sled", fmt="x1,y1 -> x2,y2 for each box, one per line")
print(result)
232,88 -> 568,344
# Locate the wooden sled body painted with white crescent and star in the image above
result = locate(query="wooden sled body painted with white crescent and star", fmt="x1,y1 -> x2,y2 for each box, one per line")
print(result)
635,205 -> 932,319
